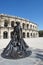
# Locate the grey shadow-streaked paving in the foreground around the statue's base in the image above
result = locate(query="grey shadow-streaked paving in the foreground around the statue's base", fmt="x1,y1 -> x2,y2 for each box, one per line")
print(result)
0,49 -> 43,65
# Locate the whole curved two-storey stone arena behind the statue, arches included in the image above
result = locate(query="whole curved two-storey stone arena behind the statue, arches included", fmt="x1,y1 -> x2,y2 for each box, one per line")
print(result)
0,14 -> 39,39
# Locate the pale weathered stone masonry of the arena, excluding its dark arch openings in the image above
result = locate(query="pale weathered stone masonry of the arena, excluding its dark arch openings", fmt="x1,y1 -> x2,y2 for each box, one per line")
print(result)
0,14 -> 38,39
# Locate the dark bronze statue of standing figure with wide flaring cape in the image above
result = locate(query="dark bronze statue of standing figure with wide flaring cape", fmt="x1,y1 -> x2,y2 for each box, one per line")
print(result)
2,22 -> 31,59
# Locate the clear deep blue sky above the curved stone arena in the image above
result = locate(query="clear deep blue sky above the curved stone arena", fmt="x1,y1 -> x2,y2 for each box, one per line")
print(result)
0,0 -> 43,30
